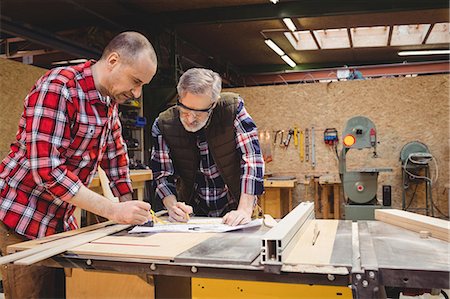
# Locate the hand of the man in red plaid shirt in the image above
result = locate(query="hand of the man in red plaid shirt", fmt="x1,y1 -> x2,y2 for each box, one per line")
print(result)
108,200 -> 151,224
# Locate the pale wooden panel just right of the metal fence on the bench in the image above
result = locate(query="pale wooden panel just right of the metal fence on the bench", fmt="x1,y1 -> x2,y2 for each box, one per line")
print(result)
285,220 -> 339,266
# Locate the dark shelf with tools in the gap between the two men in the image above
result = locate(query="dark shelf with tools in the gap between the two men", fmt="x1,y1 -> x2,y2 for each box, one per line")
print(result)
119,97 -> 147,169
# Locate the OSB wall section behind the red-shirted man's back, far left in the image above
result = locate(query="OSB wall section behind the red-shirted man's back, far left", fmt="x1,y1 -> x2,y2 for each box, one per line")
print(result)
0,58 -> 46,159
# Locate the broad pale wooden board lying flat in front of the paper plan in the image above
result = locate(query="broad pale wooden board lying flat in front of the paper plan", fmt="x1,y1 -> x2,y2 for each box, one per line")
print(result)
69,233 -> 216,260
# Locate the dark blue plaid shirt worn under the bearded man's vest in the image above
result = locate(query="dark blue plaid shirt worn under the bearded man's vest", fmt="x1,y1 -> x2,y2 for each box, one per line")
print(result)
151,98 -> 264,217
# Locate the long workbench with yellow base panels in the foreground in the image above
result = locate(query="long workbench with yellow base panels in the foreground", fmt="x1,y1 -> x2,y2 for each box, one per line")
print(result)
8,203 -> 450,298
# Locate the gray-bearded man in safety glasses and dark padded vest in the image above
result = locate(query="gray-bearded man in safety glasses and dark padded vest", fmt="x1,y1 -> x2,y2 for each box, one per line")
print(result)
151,68 -> 264,226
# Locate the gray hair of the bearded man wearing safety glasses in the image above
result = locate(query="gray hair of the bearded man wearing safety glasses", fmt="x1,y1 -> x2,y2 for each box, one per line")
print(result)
177,68 -> 222,102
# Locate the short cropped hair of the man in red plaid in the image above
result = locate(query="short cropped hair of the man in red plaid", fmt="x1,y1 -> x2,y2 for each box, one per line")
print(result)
100,31 -> 158,65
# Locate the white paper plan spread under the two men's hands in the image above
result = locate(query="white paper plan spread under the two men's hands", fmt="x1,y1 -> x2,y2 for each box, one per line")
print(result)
128,218 -> 262,234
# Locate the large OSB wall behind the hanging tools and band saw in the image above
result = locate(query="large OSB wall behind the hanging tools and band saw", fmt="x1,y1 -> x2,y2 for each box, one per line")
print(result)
229,75 -> 450,215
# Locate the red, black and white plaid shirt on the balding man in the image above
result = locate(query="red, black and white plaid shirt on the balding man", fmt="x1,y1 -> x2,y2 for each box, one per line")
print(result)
0,61 -> 132,239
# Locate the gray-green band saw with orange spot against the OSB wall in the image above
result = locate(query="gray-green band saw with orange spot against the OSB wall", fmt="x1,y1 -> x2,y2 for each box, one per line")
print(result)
339,116 -> 392,221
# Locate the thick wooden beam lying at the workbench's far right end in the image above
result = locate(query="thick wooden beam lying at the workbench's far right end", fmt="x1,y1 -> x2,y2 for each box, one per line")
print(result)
375,209 -> 450,242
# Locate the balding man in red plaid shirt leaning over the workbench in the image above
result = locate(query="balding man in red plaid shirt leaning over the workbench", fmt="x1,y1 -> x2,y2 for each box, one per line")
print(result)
0,32 -> 157,298
